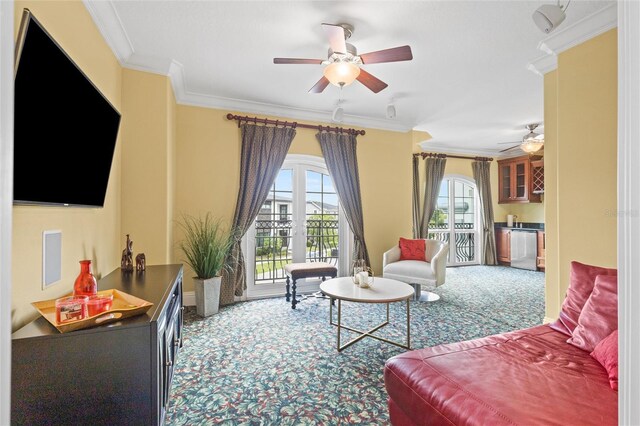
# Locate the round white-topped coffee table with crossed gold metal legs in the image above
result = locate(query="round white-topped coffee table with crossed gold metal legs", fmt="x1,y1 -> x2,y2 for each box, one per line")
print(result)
320,277 -> 414,352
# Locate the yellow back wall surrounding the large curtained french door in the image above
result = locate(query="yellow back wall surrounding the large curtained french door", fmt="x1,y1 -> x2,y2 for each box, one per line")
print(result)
174,105 -> 413,291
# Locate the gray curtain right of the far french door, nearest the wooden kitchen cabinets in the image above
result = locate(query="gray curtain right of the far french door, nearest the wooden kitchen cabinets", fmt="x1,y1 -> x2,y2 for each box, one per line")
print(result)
471,161 -> 497,265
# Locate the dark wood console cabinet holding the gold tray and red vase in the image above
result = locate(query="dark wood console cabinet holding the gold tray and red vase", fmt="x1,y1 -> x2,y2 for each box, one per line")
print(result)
11,265 -> 183,425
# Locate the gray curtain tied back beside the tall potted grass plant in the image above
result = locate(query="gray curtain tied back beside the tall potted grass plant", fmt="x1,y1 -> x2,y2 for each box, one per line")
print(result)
220,124 -> 296,305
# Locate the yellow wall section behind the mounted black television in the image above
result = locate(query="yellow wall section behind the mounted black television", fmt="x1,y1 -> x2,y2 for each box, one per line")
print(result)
11,1 -> 122,330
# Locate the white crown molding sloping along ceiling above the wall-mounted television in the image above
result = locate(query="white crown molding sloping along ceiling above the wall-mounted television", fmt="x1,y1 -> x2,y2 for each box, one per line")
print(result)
82,0 -> 134,66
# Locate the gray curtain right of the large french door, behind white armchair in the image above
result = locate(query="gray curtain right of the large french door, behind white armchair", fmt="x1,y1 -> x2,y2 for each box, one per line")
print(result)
316,132 -> 371,266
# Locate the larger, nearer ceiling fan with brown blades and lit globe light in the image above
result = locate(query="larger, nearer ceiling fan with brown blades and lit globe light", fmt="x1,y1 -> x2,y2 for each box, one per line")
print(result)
273,24 -> 413,93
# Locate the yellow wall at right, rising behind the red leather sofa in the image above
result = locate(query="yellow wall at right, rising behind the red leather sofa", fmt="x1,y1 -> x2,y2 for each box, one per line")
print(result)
545,30 -> 617,318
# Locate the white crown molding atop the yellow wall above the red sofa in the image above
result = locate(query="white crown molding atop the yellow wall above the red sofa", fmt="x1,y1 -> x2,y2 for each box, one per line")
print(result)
538,3 -> 618,55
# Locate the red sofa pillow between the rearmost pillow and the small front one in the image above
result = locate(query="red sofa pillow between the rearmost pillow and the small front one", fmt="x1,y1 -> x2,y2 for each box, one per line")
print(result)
567,275 -> 618,352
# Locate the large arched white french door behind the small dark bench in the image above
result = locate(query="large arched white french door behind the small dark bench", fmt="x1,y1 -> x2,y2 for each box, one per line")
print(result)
243,155 -> 351,298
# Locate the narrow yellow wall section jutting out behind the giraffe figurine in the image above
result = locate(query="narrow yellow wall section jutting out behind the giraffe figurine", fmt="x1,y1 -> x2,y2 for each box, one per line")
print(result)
121,69 -> 175,265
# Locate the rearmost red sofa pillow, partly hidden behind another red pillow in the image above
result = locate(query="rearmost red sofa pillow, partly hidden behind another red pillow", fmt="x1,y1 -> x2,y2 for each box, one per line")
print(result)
550,261 -> 618,336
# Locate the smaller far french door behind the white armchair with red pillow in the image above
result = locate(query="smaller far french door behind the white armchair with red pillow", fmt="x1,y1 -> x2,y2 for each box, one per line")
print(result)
429,176 -> 481,266
